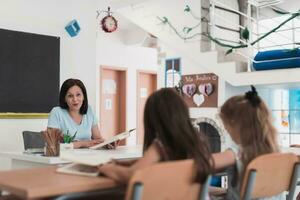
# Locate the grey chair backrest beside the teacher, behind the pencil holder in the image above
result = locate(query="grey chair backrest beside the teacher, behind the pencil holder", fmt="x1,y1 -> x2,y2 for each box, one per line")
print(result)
23,131 -> 45,150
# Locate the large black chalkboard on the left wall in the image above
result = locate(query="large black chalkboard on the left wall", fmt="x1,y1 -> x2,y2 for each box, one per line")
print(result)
0,29 -> 60,113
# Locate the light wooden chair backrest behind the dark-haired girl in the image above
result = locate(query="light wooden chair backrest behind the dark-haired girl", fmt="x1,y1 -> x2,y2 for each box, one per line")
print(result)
126,160 -> 210,200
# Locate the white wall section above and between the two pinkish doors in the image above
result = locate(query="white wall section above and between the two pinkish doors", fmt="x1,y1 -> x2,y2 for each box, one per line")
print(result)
96,31 -> 160,145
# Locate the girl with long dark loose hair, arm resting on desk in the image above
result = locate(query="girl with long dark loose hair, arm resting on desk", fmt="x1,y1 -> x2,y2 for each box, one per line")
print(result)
99,88 -> 213,184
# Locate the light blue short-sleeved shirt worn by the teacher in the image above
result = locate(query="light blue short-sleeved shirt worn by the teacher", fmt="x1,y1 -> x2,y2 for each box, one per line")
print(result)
48,106 -> 98,140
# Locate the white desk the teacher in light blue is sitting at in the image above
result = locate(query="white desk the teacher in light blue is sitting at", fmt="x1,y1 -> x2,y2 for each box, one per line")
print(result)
0,146 -> 142,169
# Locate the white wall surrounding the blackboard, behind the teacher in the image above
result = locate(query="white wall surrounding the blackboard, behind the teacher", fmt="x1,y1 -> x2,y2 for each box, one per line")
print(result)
0,0 -> 96,170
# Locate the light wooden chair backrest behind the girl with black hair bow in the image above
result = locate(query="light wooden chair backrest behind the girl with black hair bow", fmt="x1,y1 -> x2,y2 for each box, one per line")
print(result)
240,153 -> 299,200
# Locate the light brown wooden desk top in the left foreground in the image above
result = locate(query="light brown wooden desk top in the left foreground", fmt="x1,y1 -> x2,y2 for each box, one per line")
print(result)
0,166 -> 117,199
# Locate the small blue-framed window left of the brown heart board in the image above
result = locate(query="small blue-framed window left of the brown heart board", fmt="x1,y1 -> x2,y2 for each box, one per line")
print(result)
165,58 -> 181,87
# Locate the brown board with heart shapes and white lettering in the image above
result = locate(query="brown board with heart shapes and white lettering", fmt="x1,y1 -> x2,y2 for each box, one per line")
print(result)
181,73 -> 218,108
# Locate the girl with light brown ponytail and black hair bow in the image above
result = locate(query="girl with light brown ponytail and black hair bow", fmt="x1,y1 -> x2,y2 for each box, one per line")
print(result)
214,86 -> 280,200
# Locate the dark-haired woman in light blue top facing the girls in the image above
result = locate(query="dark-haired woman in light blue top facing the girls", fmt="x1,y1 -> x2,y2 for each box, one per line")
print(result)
48,79 -> 104,148
